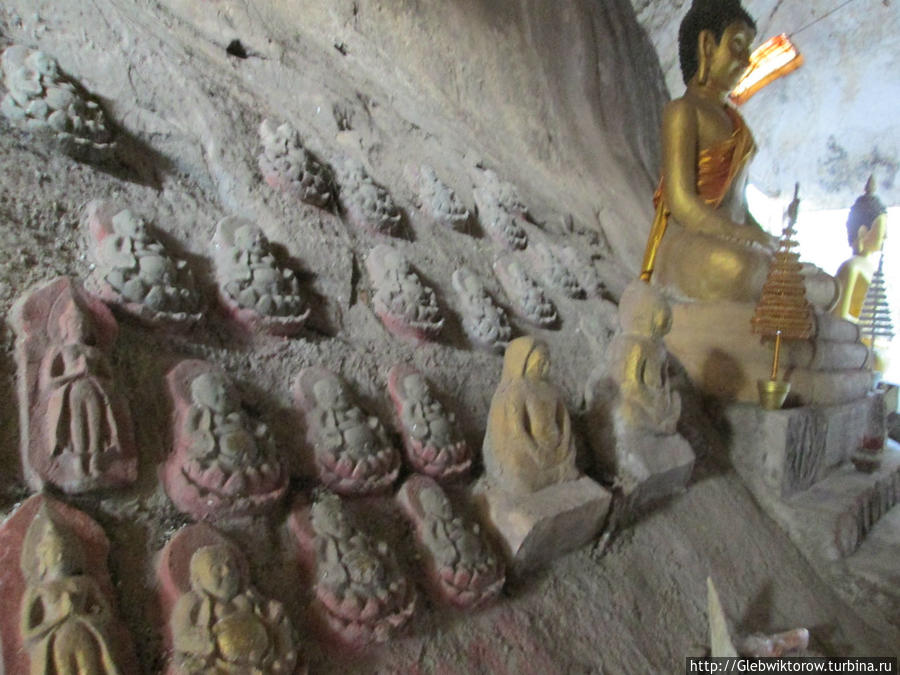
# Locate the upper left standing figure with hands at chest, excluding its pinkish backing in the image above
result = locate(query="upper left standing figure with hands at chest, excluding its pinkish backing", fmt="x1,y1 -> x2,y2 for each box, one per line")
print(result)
40,294 -> 120,477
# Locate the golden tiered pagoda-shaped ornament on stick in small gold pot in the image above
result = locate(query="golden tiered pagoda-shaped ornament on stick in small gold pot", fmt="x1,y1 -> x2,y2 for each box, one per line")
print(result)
750,183 -> 813,410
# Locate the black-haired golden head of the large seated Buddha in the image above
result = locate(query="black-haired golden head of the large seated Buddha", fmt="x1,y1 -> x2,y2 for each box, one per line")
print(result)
678,0 -> 756,93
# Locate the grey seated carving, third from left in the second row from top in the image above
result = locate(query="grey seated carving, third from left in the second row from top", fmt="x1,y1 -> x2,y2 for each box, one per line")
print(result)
366,244 -> 444,340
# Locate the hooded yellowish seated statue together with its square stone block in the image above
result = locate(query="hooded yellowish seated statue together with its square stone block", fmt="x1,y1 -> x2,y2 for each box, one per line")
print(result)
474,336 -> 611,571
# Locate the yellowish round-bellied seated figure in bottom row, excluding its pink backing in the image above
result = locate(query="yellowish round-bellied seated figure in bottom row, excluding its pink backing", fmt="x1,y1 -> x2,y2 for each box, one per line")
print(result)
170,544 -> 297,675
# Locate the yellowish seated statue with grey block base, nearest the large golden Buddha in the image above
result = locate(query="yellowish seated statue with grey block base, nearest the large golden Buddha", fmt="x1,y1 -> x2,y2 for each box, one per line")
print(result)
585,280 -> 694,510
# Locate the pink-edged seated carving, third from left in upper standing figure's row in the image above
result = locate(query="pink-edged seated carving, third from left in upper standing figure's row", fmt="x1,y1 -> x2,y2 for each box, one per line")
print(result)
294,368 -> 400,495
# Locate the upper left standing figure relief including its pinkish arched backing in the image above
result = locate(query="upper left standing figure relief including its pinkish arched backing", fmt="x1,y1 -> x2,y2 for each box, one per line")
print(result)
10,277 -> 137,494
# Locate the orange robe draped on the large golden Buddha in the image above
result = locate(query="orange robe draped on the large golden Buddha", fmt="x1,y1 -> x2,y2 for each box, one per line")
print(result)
641,106 -> 756,281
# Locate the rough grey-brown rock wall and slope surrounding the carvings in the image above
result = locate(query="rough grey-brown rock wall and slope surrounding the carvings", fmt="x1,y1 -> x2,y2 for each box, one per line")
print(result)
0,0 -> 900,673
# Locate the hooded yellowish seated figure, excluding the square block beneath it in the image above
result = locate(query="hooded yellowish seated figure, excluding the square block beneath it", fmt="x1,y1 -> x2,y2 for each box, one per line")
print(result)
483,336 -> 579,494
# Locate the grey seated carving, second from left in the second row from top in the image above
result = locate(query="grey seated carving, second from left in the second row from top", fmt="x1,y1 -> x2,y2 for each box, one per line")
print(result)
213,216 -> 309,335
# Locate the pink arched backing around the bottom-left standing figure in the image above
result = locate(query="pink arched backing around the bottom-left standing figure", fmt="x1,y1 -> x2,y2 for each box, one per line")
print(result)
0,494 -> 139,675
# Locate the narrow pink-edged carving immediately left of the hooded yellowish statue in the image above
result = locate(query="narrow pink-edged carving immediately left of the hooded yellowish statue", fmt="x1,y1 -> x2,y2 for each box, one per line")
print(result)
388,365 -> 472,481
